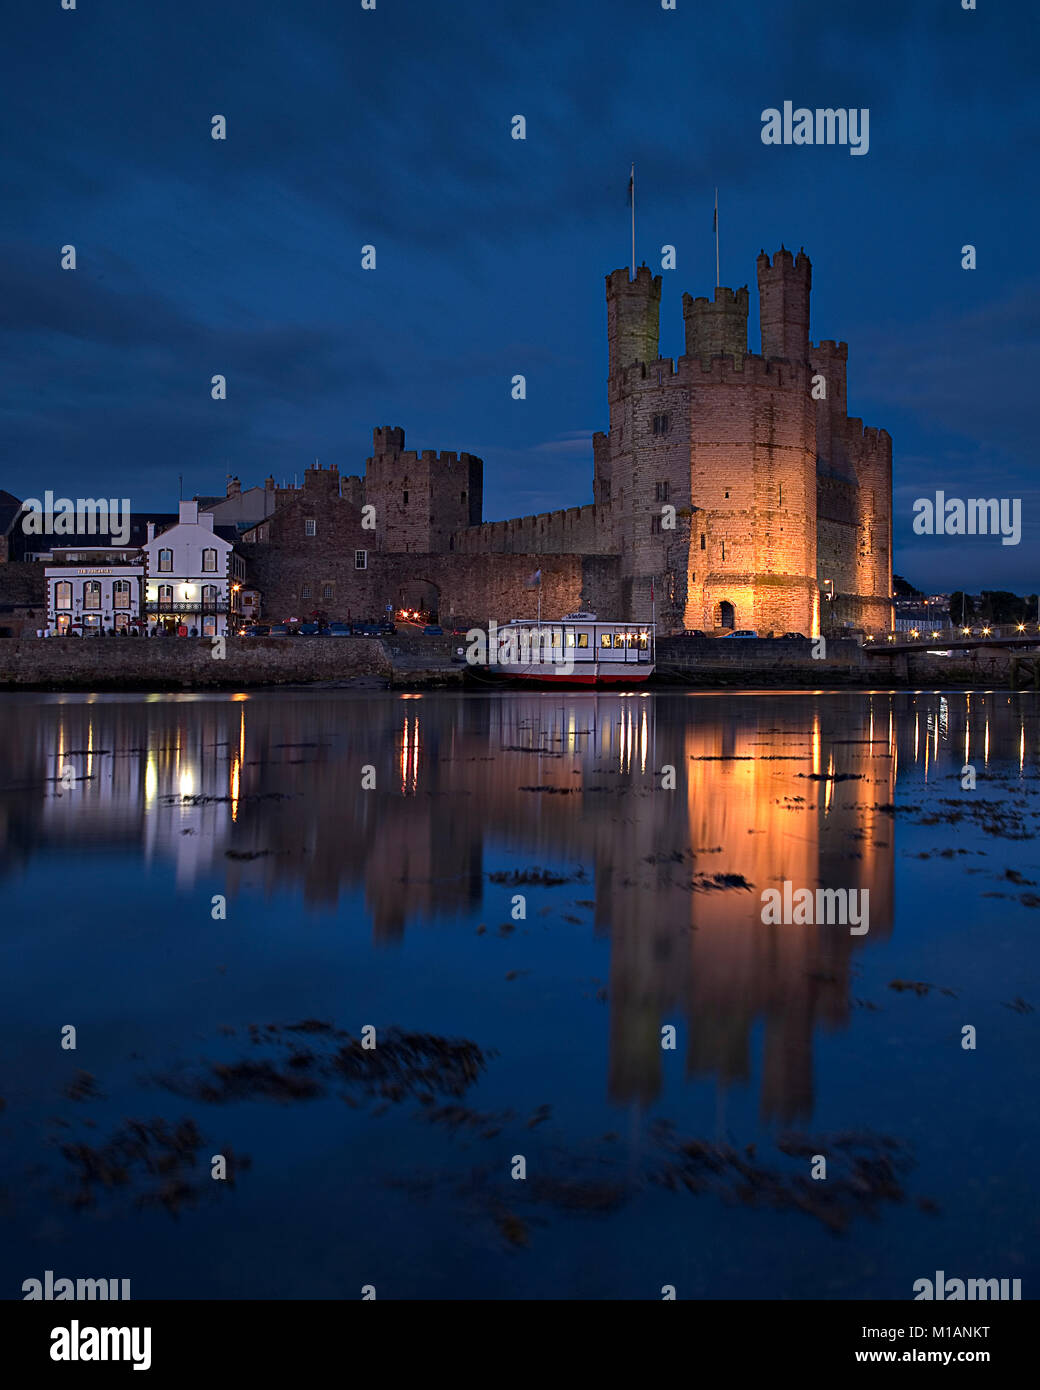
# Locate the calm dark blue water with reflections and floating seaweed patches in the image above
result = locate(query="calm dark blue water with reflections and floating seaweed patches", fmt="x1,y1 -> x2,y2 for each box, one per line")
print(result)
0,692 -> 1040,1298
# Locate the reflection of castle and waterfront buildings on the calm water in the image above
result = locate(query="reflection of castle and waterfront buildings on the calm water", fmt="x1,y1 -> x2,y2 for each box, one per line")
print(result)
0,692 -> 1027,1122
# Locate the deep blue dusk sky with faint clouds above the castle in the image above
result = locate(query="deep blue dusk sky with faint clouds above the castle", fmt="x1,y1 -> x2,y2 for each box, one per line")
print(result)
0,0 -> 1040,591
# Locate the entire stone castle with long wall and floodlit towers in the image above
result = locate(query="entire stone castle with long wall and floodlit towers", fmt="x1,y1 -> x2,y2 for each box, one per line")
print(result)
243,247 -> 891,635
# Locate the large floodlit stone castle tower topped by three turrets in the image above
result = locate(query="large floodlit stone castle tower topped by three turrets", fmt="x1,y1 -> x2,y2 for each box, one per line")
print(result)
594,247 -> 891,634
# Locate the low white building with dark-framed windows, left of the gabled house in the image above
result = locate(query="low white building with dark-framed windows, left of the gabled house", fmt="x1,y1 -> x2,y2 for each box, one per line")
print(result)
46,545 -> 145,637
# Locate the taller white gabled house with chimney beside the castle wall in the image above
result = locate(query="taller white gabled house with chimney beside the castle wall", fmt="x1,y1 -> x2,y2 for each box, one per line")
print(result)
143,502 -> 246,637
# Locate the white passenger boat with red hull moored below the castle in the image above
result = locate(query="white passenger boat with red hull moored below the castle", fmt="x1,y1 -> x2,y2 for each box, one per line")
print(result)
488,612 -> 655,685
